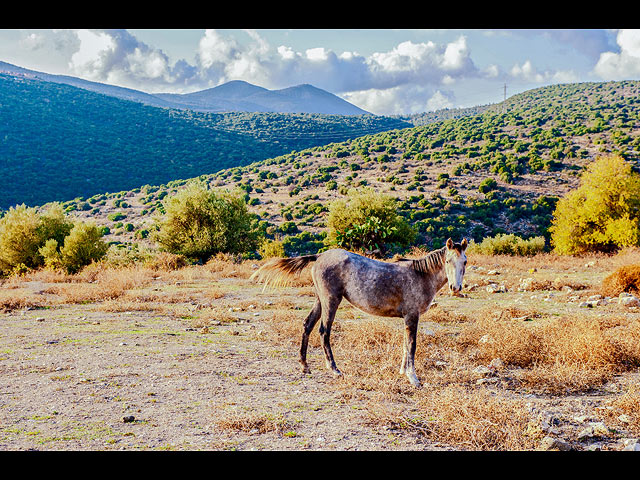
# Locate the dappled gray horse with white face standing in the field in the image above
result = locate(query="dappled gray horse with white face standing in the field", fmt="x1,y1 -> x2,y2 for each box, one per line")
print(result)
251,239 -> 467,387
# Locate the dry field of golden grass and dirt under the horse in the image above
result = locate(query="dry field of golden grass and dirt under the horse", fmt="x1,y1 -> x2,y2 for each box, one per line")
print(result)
0,250 -> 640,450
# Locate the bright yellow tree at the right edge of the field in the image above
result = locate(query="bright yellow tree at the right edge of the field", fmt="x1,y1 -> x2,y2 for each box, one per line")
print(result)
549,156 -> 640,255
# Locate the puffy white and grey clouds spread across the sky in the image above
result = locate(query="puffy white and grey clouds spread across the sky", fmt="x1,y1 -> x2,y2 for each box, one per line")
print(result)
13,30 -> 640,114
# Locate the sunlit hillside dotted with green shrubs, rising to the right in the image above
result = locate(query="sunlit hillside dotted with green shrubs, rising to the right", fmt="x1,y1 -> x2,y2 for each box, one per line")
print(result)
56,81 -> 640,254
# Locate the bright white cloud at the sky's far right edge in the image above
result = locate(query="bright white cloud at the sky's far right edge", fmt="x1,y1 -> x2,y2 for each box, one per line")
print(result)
594,30 -> 640,80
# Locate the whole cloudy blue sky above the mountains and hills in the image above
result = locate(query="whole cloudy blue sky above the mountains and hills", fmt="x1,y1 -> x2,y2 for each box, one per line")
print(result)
0,29 -> 640,115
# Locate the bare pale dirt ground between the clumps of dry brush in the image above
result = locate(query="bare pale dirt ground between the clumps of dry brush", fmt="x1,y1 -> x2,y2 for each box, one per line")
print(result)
0,253 -> 640,451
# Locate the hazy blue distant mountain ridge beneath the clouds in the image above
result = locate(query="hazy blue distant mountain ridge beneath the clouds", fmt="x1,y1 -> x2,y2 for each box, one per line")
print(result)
0,62 -> 368,115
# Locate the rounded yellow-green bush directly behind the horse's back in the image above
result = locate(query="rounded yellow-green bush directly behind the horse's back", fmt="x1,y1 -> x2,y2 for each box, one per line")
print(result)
327,188 -> 416,253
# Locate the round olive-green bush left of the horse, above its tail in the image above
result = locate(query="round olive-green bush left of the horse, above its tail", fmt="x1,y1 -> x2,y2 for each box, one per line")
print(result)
155,183 -> 258,262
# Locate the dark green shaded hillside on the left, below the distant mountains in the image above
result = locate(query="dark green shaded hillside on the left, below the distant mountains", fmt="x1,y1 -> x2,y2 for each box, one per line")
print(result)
0,74 -> 410,209
